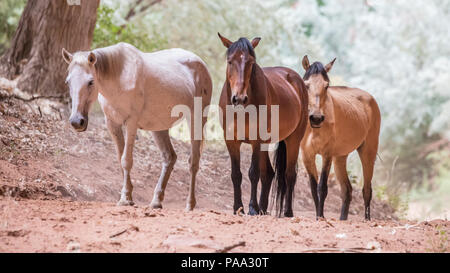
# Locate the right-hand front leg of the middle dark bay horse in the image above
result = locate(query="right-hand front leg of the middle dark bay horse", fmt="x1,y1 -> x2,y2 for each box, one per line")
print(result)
248,143 -> 261,215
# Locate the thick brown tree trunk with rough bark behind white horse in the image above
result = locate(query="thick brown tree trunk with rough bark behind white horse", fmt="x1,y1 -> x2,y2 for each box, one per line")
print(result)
0,0 -> 100,98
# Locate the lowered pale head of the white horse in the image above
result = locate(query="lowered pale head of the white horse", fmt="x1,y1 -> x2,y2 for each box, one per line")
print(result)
62,48 -> 98,132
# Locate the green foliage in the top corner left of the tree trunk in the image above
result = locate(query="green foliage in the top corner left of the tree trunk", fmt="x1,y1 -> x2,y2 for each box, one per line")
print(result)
0,0 -> 26,55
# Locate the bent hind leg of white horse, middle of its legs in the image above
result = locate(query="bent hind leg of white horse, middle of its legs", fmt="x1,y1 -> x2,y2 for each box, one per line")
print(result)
150,130 -> 177,208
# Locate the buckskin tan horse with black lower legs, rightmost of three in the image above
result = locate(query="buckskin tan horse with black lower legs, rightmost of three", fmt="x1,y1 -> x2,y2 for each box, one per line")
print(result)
301,56 -> 381,220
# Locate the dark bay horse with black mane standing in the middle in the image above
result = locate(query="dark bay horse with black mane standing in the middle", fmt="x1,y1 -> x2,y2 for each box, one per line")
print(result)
219,34 -> 308,217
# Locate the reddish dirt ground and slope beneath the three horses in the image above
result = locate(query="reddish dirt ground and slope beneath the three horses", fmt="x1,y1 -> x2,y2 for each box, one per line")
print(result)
0,90 -> 450,252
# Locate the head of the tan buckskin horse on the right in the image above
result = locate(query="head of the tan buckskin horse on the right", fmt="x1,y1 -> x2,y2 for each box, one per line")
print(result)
302,56 -> 336,128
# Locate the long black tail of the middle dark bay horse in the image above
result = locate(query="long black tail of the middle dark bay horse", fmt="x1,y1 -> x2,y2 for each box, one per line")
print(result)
274,141 -> 287,217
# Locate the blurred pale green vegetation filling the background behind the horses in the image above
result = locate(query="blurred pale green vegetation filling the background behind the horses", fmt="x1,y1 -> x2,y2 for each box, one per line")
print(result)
0,0 -> 450,218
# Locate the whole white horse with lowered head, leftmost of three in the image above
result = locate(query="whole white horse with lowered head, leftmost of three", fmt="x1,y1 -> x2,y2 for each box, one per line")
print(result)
62,43 -> 212,210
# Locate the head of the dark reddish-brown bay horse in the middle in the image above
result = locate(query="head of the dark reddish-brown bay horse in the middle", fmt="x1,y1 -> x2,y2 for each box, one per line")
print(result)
218,33 -> 261,106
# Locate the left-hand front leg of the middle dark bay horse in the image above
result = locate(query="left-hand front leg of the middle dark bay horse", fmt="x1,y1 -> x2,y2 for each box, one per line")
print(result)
225,141 -> 244,214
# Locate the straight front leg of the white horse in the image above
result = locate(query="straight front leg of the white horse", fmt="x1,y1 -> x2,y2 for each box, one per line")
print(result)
117,121 -> 137,206
